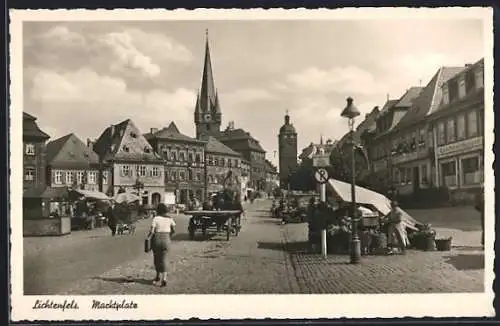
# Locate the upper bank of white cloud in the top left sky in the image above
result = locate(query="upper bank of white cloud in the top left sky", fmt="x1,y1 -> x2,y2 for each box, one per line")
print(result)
24,25 -> 192,81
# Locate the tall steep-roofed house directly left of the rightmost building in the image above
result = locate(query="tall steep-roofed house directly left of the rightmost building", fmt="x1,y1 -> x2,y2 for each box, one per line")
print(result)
382,67 -> 464,195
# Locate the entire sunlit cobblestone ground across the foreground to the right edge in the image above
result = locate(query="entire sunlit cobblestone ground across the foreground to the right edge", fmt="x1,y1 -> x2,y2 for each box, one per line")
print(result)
52,201 -> 484,294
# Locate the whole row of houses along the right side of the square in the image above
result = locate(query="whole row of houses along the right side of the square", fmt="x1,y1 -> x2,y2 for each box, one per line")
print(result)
337,59 -> 484,194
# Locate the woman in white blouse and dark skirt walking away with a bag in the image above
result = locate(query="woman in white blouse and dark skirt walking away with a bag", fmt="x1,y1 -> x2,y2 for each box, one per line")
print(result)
147,203 -> 175,287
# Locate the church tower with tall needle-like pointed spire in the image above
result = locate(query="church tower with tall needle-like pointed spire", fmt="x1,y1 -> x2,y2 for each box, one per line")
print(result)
194,30 -> 222,138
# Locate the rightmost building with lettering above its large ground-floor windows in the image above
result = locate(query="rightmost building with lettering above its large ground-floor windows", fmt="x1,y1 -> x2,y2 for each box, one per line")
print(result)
429,59 -> 484,192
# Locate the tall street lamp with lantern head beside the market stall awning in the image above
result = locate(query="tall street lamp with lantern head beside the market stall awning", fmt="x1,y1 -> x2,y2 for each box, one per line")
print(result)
341,97 -> 361,264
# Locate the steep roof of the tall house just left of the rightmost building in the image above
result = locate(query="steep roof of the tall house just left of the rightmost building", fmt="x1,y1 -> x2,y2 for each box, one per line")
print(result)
393,67 -> 464,130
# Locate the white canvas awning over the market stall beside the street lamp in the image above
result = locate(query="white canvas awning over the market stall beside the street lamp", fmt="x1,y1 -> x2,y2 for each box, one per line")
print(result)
327,179 -> 422,230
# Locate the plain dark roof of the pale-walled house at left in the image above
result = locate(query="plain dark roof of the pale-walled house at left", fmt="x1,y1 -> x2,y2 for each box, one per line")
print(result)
46,133 -> 99,165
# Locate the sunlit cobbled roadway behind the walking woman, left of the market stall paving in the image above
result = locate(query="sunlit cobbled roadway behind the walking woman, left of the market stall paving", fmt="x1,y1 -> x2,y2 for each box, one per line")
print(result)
63,201 -> 298,294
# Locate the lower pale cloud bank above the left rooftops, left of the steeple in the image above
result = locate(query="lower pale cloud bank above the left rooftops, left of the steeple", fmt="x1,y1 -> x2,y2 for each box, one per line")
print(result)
27,69 -> 196,139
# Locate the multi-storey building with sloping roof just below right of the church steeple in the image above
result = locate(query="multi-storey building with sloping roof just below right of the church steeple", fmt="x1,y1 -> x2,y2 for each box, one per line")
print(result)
201,136 -> 241,193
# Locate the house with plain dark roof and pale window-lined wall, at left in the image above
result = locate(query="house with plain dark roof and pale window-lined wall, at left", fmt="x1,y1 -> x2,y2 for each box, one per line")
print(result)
46,133 -> 101,191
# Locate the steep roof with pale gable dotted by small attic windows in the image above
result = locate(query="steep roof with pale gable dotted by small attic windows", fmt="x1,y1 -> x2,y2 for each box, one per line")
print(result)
94,119 -> 161,162
